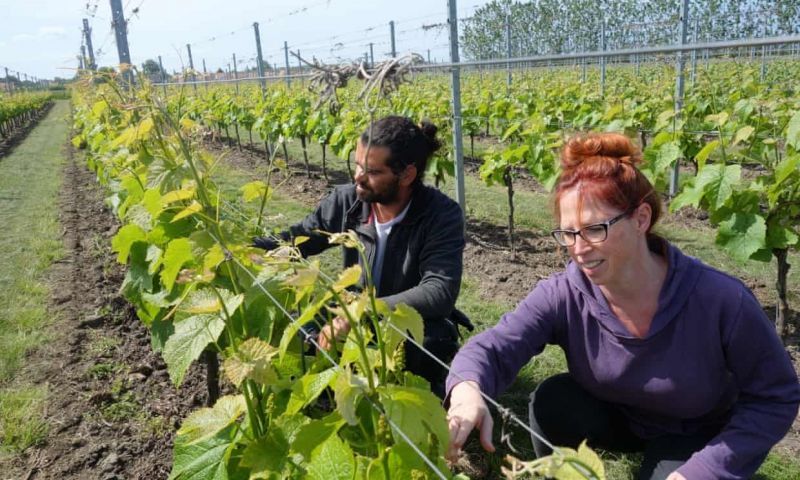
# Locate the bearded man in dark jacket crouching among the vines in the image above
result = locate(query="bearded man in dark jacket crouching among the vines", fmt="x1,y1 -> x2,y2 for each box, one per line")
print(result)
255,116 -> 472,396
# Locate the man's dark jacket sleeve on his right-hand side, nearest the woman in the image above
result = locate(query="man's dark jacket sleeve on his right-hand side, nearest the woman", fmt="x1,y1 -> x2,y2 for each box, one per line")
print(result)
381,199 -> 465,319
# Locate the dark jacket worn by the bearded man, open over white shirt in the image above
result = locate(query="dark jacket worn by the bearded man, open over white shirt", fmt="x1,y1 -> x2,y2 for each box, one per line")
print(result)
254,184 -> 464,337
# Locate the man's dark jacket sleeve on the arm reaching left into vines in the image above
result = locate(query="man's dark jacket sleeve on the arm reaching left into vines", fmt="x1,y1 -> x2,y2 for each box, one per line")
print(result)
253,189 -> 346,257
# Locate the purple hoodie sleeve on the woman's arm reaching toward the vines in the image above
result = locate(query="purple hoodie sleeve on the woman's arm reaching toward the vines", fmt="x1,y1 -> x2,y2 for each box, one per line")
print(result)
446,277 -> 564,398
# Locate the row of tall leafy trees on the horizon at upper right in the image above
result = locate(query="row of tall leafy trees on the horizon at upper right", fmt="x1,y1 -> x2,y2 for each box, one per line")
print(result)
460,0 -> 800,59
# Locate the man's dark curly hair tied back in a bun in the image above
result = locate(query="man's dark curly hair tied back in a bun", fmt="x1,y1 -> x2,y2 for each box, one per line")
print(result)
361,115 -> 442,184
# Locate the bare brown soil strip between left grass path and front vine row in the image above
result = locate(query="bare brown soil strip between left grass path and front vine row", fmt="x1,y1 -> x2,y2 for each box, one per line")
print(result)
0,142 -> 205,480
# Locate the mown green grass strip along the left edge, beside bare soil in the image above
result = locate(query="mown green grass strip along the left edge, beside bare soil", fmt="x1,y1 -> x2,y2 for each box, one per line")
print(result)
0,101 -> 69,452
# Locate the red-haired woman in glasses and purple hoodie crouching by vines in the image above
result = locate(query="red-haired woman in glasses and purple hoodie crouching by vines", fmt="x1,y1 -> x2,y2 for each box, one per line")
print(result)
447,133 -> 800,480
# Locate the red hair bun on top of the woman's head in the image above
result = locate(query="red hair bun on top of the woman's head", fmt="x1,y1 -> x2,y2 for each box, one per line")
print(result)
561,133 -> 642,170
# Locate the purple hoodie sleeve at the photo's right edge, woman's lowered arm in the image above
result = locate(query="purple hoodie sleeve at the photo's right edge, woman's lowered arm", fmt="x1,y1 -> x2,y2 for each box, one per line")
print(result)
678,289 -> 800,480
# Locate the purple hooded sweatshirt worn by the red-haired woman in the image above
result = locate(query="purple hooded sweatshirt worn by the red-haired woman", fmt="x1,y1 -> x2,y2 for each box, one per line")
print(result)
447,246 -> 800,480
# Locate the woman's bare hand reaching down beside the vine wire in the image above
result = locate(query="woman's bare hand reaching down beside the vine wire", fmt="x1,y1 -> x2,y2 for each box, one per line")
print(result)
447,381 -> 494,461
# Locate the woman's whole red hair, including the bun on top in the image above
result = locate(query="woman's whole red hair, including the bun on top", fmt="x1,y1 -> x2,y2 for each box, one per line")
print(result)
554,133 -> 661,235
